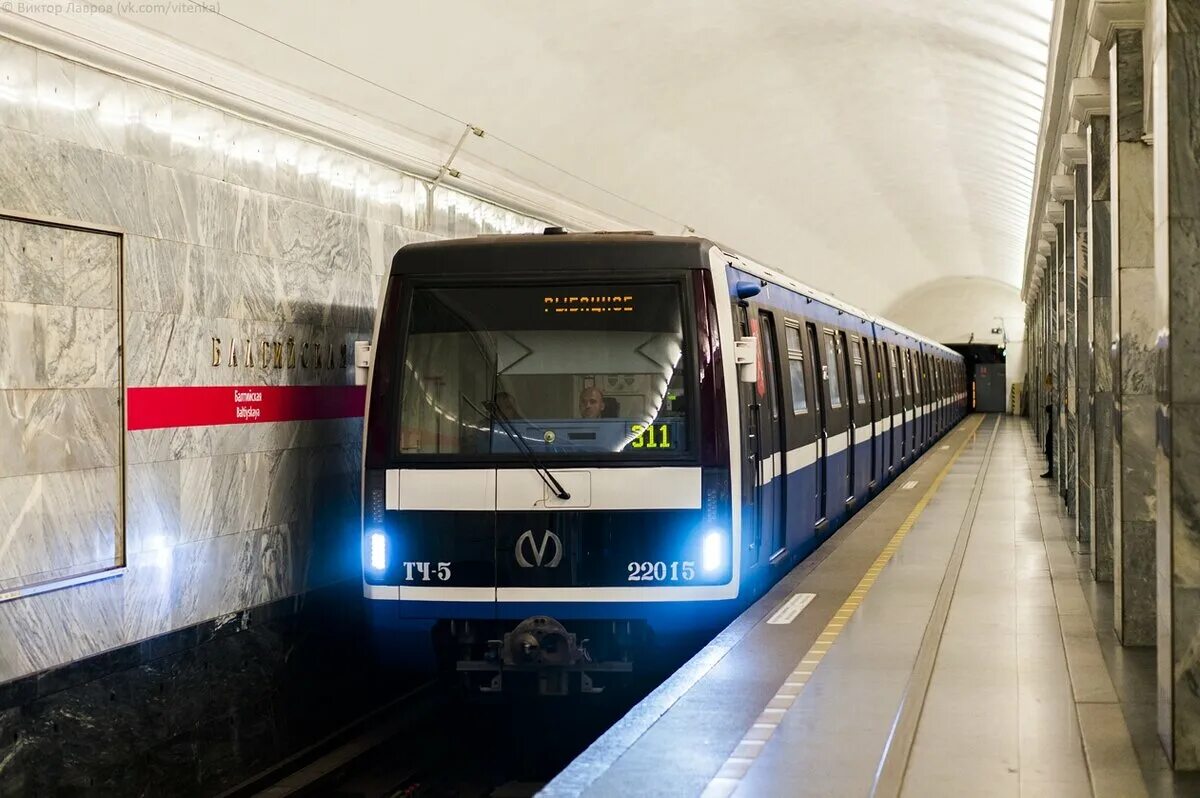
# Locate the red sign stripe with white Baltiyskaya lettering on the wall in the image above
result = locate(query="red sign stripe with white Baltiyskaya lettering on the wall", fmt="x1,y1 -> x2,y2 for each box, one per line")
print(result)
126,385 -> 366,430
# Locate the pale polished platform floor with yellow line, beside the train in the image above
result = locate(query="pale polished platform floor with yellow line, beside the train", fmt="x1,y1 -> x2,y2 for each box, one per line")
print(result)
542,415 -> 1171,798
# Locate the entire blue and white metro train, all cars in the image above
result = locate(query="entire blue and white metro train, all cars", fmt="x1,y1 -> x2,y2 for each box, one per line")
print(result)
362,228 -> 967,694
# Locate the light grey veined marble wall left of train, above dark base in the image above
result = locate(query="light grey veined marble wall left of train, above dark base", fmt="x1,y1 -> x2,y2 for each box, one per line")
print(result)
0,32 -> 545,686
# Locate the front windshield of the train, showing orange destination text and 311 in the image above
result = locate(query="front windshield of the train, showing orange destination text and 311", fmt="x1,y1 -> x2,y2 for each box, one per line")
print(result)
397,283 -> 690,460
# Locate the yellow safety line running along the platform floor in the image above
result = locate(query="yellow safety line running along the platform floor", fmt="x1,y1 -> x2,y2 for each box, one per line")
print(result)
703,415 -> 983,798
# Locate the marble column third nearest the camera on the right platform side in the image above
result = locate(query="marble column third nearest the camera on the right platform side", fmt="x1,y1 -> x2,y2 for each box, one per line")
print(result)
1087,116 -> 1114,582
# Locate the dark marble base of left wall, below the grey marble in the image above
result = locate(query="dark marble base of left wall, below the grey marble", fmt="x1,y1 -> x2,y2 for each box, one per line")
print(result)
0,581 -> 422,798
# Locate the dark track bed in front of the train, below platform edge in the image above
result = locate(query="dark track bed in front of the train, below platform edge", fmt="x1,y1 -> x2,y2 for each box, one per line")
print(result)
222,679 -> 654,798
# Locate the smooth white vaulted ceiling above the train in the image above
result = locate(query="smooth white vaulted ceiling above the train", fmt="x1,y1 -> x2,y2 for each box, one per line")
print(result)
114,0 -> 1052,330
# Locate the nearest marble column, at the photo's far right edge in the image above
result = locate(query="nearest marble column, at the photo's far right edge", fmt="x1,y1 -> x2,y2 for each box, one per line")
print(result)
1147,0 -> 1200,770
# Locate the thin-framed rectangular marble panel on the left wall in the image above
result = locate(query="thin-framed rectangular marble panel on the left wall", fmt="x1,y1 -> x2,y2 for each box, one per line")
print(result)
0,216 -> 124,595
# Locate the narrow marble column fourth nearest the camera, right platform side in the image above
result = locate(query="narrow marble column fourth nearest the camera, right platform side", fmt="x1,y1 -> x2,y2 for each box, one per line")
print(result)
1074,161 -> 1092,551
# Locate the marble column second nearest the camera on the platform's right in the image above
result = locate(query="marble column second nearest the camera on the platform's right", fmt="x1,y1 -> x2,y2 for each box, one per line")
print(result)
1109,30 -> 1156,646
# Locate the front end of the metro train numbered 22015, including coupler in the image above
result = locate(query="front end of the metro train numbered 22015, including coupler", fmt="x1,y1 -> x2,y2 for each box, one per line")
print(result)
362,234 -> 738,692
